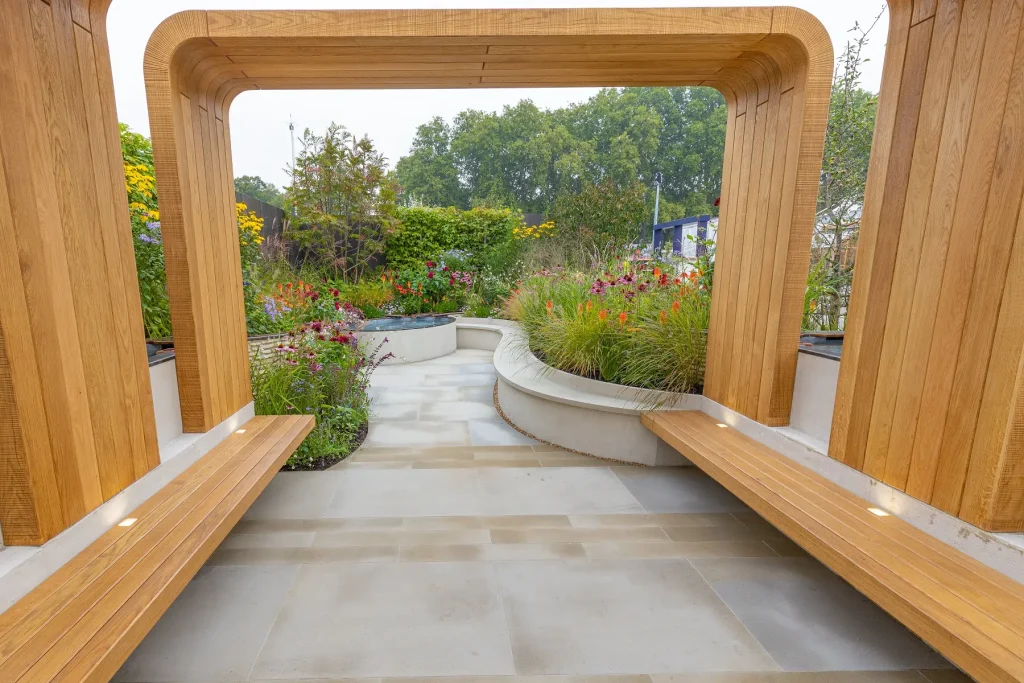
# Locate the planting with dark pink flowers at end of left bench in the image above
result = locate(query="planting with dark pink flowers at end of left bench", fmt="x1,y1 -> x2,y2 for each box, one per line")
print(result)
250,322 -> 386,469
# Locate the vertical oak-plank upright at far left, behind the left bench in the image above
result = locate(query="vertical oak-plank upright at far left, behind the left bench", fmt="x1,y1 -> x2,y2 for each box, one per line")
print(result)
0,0 -> 159,545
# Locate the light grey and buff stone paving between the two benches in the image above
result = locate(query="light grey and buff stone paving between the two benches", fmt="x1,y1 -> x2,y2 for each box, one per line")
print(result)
116,350 -> 967,683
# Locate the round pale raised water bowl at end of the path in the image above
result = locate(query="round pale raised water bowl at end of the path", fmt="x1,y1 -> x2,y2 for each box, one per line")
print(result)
355,315 -> 457,366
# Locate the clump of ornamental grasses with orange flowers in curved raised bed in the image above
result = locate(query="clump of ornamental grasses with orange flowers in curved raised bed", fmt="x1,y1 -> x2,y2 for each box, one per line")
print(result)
505,263 -> 711,392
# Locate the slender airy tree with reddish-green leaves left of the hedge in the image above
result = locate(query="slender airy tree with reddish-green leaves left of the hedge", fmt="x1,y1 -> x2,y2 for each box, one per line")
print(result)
285,123 -> 397,282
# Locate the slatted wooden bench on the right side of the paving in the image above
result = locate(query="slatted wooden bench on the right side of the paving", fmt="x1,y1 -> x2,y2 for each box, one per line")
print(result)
643,412 -> 1024,681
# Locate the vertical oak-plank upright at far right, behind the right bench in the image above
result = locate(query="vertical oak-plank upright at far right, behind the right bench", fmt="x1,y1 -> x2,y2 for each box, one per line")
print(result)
829,0 -> 1024,531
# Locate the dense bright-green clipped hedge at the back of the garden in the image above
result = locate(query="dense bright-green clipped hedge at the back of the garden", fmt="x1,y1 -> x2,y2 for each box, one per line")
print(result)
384,207 -> 522,270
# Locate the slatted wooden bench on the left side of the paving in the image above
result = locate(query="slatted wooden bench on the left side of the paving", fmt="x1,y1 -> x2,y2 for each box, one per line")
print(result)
0,416 -> 313,683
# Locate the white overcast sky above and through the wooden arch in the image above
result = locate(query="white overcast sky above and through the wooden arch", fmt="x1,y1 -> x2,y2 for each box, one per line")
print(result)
108,0 -> 888,186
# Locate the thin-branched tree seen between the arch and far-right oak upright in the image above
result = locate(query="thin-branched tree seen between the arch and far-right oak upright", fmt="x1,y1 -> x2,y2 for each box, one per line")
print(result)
804,8 -> 885,330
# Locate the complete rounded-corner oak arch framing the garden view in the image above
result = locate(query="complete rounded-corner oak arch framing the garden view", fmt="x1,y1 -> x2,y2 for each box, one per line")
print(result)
145,8 -> 833,431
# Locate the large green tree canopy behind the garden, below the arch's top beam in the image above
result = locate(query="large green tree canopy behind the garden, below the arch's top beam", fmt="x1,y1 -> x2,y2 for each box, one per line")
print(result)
396,87 -> 726,219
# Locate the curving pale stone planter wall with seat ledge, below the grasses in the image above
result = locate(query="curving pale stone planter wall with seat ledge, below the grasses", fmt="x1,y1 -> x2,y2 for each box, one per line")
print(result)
457,318 -> 701,465
